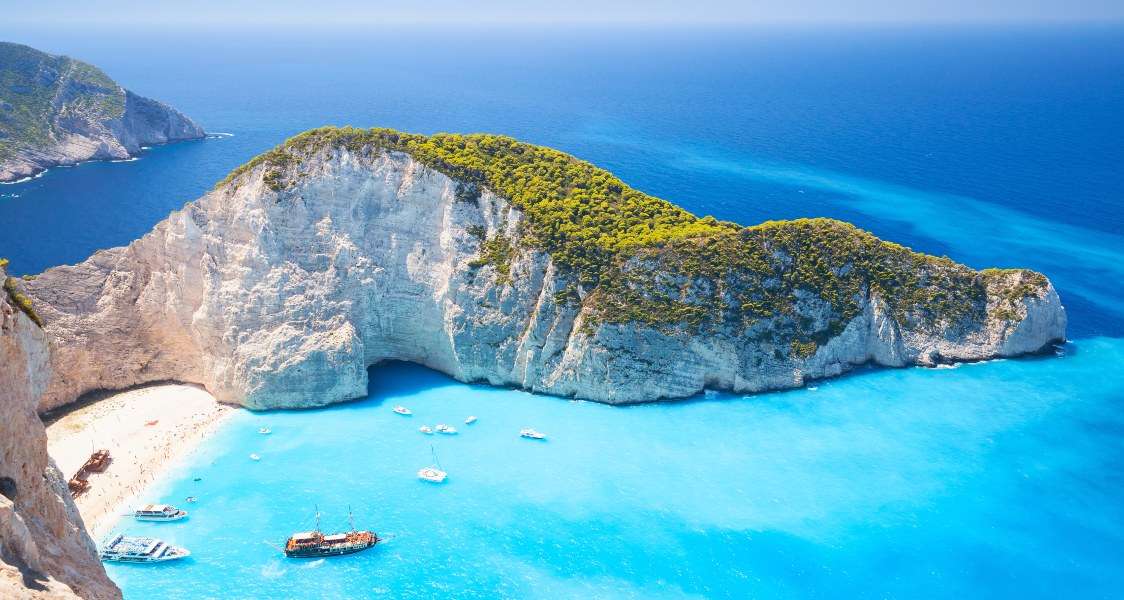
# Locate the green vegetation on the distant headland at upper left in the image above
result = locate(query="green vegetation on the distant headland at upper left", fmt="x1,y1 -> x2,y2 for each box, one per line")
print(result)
0,42 -> 125,161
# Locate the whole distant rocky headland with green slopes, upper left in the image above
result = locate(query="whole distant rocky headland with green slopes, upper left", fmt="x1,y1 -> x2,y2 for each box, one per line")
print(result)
0,43 -> 203,181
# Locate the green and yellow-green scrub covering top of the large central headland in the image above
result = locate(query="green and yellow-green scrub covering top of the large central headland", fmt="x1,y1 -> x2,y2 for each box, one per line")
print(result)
219,127 -> 1045,356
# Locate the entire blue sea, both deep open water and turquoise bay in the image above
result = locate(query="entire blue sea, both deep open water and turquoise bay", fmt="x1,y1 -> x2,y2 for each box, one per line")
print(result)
0,24 -> 1124,600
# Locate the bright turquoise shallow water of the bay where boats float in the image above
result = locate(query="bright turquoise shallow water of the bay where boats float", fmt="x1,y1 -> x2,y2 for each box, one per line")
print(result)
101,339 -> 1124,599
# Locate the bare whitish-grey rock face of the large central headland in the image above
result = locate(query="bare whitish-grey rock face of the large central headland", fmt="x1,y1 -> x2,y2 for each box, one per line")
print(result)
22,147 -> 1066,410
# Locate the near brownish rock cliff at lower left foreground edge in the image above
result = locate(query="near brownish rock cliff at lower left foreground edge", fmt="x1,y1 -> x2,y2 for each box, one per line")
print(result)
0,267 -> 121,599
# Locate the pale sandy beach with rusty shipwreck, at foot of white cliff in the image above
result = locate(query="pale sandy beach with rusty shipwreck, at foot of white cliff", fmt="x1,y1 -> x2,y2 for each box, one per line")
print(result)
47,384 -> 236,540
